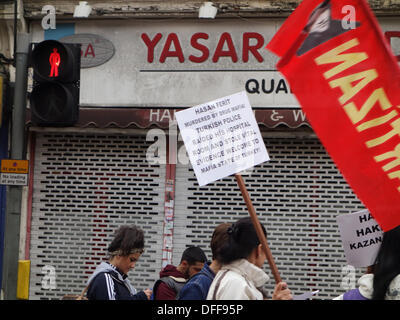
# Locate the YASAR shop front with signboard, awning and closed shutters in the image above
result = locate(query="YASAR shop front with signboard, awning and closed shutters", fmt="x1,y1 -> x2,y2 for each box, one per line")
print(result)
25,18 -> 399,299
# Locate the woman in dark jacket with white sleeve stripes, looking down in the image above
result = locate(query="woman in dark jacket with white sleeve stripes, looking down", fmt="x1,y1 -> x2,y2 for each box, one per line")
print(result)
87,225 -> 151,300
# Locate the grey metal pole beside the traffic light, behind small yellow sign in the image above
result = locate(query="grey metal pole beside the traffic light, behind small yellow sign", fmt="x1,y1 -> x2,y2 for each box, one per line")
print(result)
3,33 -> 30,300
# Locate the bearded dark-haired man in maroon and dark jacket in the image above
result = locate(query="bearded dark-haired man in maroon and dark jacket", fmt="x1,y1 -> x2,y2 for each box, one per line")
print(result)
153,247 -> 207,300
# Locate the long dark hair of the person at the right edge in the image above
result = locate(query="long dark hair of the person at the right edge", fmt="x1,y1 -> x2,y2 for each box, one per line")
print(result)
372,226 -> 400,300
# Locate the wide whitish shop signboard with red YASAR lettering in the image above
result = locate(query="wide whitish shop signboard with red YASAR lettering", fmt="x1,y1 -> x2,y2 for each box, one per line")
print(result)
32,19 -> 299,108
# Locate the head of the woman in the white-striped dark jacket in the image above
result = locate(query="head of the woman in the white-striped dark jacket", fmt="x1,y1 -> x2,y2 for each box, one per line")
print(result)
107,225 -> 144,274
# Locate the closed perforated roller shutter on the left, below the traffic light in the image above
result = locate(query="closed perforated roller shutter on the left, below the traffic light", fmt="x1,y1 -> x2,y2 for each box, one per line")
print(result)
30,133 -> 165,299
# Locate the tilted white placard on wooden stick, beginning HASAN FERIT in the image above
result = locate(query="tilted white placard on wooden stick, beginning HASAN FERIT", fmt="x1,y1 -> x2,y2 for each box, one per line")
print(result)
175,91 -> 269,186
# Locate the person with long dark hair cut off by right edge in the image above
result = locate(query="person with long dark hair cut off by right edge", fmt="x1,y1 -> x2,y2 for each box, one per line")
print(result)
334,226 -> 400,300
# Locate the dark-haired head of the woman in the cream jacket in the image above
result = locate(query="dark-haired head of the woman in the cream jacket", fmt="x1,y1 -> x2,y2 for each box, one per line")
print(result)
219,218 -> 267,268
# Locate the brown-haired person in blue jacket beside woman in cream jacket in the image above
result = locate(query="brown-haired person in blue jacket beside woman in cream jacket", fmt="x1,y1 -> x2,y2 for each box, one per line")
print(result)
179,223 -> 231,300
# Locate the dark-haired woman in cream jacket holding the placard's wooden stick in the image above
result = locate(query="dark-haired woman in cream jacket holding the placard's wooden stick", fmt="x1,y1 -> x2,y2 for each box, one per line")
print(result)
207,218 -> 292,300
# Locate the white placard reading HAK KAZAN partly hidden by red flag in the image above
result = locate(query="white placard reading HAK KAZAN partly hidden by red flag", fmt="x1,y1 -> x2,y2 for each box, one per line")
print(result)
336,209 -> 383,267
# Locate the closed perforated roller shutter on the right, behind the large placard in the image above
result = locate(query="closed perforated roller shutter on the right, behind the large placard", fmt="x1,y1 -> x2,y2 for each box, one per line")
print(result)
173,138 -> 364,299
